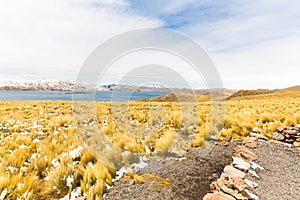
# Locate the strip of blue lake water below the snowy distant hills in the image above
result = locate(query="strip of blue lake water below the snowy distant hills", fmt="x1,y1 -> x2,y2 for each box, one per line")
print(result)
0,90 -> 167,102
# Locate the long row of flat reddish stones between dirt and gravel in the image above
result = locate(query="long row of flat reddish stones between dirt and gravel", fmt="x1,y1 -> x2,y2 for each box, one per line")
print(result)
203,137 -> 263,200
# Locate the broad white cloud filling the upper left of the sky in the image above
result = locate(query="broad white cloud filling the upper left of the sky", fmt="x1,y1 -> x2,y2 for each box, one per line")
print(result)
0,0 -> 161,79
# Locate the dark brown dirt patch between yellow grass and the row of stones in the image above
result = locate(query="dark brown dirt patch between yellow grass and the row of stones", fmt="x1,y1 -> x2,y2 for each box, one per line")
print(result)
103,142 -> 238,200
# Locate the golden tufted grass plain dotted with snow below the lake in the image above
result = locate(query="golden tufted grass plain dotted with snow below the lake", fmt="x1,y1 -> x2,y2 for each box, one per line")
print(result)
0,91 -> 300,199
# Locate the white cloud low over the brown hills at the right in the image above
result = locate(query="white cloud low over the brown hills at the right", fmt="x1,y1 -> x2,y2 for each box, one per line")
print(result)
212,36 -> 300,89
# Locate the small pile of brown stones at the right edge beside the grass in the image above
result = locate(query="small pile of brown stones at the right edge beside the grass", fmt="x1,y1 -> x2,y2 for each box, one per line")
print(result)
272,124 -> 300,147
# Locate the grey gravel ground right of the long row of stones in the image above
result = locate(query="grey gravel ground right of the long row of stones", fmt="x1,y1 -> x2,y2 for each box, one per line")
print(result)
248,141 -> 300,200
